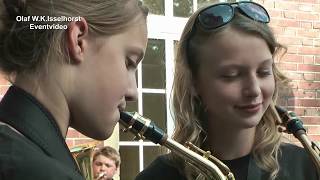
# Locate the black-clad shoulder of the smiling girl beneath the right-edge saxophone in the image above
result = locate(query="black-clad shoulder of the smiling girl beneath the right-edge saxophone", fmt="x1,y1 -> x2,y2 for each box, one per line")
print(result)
279,143 -> 318,180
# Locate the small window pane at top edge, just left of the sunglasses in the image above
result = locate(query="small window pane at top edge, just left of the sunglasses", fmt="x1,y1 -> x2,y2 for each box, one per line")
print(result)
173,0 -> 193,17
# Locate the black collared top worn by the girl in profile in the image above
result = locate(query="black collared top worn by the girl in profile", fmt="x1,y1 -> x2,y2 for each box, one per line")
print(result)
0,86 -> 83,180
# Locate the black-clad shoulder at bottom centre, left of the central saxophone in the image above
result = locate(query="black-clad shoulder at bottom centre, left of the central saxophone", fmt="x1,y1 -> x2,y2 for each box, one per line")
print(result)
136,155 -> 185,180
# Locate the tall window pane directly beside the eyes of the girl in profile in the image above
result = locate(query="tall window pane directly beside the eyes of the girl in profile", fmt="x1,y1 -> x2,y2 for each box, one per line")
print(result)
142,39 -> 166,89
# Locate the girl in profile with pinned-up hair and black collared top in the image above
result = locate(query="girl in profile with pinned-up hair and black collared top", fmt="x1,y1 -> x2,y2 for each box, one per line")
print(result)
0,0 -> 148,180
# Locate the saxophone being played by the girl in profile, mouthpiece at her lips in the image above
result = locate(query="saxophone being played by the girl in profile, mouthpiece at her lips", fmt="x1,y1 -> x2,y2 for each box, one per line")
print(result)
120,112 -> 234,180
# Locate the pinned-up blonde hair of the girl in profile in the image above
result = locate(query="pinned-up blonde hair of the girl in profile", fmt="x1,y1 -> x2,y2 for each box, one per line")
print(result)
0,0 -> 148,74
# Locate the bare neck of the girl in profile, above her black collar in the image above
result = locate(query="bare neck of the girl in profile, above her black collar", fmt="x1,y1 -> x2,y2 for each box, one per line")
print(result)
14,71 -> 70,137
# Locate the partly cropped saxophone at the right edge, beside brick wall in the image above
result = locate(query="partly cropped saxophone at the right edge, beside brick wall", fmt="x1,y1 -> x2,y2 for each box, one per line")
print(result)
275,106 -> 320,175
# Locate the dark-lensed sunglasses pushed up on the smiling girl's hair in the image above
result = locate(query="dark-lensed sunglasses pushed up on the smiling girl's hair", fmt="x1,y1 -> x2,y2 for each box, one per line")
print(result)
197,1 -> 270,30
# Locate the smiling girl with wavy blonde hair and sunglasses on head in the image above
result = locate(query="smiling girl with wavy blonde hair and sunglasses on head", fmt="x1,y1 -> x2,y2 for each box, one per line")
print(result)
136,2 -> 317,180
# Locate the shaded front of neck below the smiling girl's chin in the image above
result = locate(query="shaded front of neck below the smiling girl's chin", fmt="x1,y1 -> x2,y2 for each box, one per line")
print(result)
207,120 -> 256,160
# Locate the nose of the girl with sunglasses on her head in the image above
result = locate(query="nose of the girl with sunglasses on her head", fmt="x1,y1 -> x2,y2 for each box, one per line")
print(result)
243,75 -> 261,98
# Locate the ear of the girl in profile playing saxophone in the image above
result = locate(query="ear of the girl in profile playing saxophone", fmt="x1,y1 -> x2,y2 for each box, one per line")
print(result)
67,18 -> 89,63
